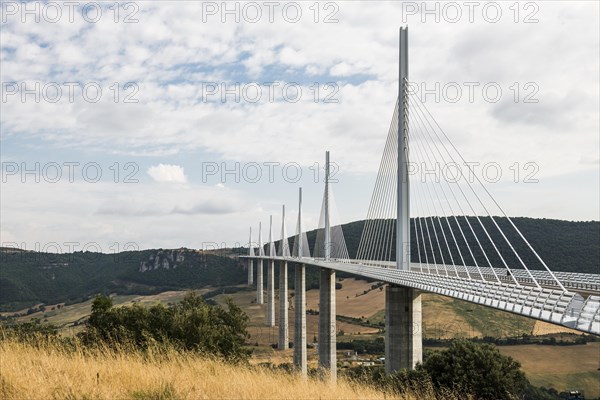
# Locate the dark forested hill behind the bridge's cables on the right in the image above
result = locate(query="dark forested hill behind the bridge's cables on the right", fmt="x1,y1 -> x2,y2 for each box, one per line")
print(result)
290,217 -> 600,274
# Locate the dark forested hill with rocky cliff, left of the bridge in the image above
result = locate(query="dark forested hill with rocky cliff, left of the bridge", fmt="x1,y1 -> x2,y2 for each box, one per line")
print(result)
0,248 -> 245,310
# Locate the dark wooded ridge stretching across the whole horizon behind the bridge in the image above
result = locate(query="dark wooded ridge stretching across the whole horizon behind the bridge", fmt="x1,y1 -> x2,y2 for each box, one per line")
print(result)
0,217 -> 600,311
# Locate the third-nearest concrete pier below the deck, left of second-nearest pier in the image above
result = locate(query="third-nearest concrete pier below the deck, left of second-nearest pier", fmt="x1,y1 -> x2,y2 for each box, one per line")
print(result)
294,264 -> 307,376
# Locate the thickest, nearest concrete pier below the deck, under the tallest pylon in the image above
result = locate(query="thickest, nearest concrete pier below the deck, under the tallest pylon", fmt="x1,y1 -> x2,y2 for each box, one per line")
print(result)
385,285 -> 423,373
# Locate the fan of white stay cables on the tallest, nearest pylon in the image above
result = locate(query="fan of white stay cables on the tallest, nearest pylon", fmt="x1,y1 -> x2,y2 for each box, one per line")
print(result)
356,91 -> 564,290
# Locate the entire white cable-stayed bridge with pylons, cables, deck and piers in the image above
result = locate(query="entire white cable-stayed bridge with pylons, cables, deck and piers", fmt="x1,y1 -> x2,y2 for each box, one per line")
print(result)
243,28 -> 600,379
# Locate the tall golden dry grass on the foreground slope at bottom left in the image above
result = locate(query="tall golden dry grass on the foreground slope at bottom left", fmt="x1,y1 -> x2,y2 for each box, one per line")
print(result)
0,339 -> 464,400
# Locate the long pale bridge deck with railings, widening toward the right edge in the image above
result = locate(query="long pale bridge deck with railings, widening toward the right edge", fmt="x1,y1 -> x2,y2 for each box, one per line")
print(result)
241,256 -> 600,335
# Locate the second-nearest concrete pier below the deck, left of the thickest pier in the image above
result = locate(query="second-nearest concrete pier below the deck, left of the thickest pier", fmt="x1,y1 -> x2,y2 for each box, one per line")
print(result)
319,268 -> 337,381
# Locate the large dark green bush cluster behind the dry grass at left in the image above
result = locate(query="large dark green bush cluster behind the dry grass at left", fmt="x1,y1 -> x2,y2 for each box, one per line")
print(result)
80,292 -> 250,361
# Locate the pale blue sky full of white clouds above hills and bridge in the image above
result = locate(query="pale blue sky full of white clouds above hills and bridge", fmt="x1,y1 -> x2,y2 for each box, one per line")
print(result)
0,1 -> 600,252
